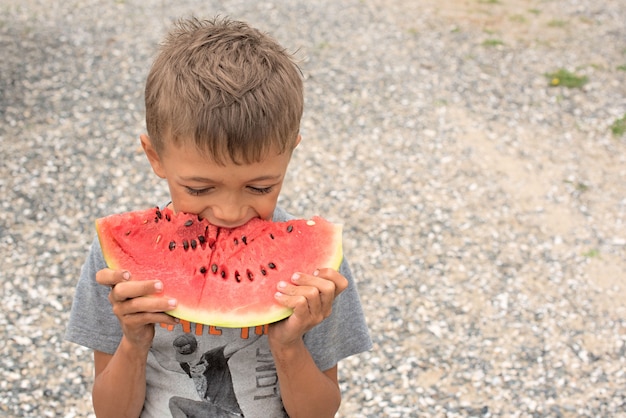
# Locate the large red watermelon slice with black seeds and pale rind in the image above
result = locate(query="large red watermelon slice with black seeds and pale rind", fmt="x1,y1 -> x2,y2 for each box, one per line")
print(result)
96,208 -> 343,328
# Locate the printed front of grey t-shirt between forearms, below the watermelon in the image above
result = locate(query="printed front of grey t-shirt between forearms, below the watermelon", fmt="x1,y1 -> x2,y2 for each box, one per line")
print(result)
151,321 -> 286,418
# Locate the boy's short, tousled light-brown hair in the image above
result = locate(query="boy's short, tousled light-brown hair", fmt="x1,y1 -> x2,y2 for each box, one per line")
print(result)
145,18 -> 303,164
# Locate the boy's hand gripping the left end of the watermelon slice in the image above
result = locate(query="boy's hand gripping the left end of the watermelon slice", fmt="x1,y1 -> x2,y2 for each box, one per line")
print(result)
96,269 -> 178,352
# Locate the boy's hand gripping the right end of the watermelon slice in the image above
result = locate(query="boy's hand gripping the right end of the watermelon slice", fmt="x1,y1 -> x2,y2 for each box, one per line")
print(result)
269,268 -> 348,346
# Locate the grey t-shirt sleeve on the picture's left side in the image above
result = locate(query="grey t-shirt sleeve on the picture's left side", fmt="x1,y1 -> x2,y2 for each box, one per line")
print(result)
65,238 -> 122,354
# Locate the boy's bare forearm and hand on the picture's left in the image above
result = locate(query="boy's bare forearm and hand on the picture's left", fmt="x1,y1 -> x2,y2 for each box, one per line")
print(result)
92,269 -> 177,418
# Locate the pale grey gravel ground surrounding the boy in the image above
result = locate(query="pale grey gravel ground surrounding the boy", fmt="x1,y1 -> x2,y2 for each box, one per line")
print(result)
0,0 -> 626,417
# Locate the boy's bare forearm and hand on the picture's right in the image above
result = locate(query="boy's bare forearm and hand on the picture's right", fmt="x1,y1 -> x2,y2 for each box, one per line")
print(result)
268,269 -> 348,418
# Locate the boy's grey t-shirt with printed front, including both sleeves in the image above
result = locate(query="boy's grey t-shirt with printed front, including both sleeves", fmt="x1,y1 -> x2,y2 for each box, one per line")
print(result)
65,208 -> 372,418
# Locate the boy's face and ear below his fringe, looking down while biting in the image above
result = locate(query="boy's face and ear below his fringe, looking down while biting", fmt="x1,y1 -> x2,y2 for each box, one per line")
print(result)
141,135 -> 298,228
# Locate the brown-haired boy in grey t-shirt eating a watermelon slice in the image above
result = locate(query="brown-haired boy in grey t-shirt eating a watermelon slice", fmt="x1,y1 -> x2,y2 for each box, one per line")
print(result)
66,19 -> 371,418
